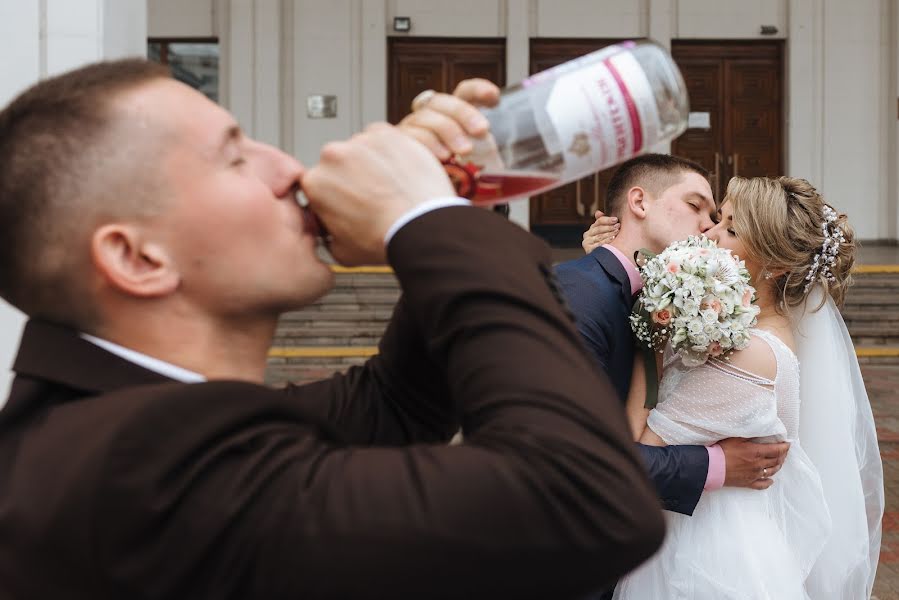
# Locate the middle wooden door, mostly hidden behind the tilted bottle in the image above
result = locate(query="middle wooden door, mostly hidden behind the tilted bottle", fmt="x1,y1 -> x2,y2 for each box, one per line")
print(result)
530,38 -> 620,247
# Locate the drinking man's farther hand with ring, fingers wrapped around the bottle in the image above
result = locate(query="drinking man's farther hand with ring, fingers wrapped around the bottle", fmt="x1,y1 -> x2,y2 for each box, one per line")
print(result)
397,79 -> 499,160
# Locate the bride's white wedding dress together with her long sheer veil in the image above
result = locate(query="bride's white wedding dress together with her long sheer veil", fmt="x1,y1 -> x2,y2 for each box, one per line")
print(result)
614,286 -> 884,600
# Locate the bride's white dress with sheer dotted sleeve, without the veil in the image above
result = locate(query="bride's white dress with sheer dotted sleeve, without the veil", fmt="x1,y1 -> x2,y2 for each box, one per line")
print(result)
614,330 -> 831,600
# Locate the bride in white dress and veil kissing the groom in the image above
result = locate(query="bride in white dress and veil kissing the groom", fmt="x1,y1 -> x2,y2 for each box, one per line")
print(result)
585,177 -> 884,600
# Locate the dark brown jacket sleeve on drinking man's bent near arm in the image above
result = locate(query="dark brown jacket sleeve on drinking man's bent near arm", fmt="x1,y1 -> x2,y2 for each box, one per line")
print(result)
96,207 -> 664,599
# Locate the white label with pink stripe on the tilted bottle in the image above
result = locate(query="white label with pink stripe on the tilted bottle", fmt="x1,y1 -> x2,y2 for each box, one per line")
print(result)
546,51 -> 659,179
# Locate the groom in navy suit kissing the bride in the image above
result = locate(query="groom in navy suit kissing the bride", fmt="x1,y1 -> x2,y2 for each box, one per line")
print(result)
556,154 -> 789,515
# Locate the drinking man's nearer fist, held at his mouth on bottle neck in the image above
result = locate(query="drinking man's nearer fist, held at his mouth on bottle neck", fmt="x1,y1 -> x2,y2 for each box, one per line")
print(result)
302,123 -> 455,265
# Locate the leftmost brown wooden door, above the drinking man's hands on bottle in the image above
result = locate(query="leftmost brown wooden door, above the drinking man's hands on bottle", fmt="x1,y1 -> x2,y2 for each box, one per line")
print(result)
387,37 -> 506,123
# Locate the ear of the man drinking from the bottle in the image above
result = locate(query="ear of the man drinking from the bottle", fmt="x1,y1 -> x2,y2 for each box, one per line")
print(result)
91,223 -> 181,298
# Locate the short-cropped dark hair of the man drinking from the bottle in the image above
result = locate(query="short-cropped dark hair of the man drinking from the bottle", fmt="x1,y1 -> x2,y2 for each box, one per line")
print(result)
0,59 -> 169,325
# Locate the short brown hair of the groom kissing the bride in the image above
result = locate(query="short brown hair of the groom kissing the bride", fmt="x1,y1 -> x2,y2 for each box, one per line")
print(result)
606,154 -> 709,218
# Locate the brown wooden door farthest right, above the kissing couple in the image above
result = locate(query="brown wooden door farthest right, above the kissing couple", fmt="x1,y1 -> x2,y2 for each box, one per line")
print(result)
671,41 -> 784,201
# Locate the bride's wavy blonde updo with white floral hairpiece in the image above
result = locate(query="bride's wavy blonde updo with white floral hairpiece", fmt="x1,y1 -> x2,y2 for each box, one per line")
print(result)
725,177 -> 856,311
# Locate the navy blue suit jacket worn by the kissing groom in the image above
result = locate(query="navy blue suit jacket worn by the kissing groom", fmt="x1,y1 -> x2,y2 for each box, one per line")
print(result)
555,246 -> 709,515
